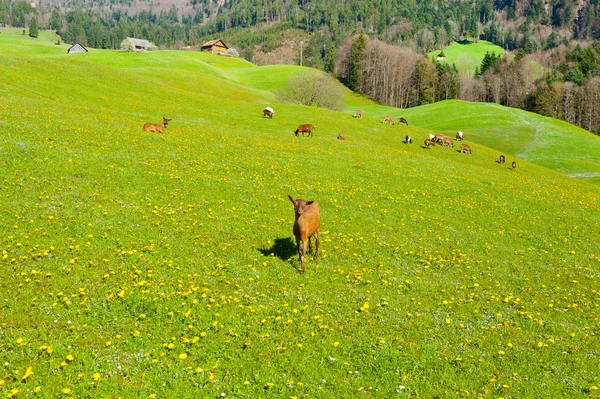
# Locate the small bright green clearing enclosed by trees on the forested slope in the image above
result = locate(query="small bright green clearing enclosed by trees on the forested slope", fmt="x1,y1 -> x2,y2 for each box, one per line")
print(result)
427,40 -> 504,75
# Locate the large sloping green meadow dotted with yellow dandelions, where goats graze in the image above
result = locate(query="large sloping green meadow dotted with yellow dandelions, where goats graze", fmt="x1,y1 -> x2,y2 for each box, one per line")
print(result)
0,30 -> 600,399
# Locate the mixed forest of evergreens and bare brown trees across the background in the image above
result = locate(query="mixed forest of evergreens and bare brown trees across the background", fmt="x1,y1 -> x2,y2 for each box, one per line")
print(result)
0,0 -> 600,134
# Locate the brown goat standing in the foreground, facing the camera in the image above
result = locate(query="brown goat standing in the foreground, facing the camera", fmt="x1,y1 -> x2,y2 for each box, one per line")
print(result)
288,195 -> 321,273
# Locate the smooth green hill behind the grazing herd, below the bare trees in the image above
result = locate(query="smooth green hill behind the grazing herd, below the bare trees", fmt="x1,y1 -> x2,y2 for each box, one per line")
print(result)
348,100 -> 600,184
